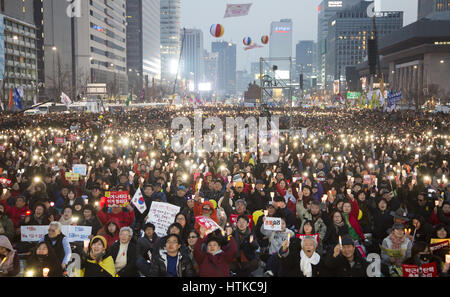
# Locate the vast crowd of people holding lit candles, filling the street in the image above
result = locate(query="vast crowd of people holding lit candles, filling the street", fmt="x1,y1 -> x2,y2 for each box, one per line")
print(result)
0,106 -> 450,277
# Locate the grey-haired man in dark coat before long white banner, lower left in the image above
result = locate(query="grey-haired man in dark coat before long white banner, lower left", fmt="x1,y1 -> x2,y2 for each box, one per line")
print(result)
39,222 -> 72,269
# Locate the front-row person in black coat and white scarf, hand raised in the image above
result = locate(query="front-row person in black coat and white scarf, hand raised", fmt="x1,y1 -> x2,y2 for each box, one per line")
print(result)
278,236 -> 323,277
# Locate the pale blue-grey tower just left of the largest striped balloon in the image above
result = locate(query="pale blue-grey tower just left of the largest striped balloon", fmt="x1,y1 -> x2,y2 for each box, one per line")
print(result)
181,29 -> 204,90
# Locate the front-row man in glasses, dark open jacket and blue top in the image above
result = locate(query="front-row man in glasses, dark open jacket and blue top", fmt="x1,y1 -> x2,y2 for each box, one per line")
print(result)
150,234 -> 195,277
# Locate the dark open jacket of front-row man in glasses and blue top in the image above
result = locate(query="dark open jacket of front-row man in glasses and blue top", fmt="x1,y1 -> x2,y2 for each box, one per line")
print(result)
150,249 -> 195,277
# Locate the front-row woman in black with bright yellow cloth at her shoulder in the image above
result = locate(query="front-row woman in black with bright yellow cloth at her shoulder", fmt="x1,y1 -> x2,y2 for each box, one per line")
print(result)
80,235 -> 117,277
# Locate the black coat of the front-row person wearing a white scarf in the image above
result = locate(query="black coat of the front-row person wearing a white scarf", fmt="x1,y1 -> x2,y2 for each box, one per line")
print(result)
279,237 -> 324,277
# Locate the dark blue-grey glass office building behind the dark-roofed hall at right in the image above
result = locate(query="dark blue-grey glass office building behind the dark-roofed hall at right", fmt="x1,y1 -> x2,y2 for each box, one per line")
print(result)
326,1 -> 403,84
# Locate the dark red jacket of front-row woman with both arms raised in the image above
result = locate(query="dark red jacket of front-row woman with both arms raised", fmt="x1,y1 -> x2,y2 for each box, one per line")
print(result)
194,237 -> 237,277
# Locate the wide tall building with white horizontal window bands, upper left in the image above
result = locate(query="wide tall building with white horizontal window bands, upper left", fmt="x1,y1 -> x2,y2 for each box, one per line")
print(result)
43,0 -> 129,98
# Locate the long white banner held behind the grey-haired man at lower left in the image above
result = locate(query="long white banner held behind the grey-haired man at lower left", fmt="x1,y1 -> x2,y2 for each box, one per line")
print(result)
20,225 -> 92,242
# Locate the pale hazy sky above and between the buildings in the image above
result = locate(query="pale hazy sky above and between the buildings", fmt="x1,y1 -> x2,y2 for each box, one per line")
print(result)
181,0 -> 418,71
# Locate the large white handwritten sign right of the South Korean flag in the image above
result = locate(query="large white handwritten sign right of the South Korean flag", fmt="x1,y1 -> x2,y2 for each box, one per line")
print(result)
146,202 -> 180,237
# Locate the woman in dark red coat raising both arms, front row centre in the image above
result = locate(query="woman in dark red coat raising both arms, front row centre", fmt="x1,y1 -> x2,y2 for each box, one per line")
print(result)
194,227 -> 241,277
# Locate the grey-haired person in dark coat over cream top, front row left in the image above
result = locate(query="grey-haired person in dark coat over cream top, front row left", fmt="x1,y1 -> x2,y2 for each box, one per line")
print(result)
108,227 -> 138,277
